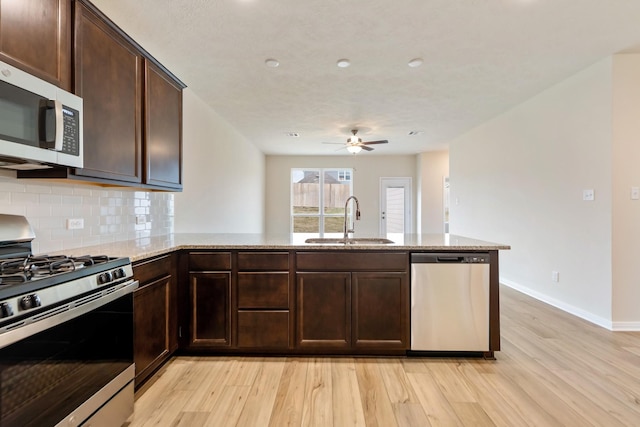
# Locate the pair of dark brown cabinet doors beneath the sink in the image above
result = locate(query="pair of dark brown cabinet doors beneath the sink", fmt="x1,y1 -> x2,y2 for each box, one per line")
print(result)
296,272 -> 409,350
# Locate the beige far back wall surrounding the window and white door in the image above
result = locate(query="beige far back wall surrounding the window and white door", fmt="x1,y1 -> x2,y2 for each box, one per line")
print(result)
265,153 -> 416,236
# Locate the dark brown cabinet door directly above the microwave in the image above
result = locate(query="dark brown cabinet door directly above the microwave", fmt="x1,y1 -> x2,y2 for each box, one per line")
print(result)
0,0 -> 71,90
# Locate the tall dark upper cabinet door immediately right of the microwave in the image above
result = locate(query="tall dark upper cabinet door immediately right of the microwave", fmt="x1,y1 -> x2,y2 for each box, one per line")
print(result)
75,2 -> 142,183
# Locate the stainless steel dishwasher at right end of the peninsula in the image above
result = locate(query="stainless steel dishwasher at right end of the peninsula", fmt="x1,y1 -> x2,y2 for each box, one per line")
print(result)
411,253 -> 490,352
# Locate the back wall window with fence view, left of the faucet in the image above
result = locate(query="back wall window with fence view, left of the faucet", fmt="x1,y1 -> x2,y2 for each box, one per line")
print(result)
291,169 -> 353,236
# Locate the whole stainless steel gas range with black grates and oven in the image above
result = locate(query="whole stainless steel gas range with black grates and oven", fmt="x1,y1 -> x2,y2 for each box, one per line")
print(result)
0,214 -> 138,427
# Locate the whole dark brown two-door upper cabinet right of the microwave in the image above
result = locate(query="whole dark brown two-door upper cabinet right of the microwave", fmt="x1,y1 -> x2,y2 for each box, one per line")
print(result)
16,0 -> 185,191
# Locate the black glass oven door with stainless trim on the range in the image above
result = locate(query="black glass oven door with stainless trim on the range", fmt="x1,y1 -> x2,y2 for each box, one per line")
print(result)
0,281 -> 137,427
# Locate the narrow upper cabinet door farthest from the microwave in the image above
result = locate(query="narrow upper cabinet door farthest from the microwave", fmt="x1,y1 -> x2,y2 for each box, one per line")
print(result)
144,61 -> 182,189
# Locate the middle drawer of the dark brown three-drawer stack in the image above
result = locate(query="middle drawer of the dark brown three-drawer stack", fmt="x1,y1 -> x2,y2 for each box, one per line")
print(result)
238,273 -> 289,309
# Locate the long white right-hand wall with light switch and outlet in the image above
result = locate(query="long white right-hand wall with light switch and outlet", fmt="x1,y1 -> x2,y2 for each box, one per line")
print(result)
450,58 -> 612,327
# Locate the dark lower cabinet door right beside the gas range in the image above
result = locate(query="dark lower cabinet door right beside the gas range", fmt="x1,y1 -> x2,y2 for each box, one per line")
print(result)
133,276 -> 171,383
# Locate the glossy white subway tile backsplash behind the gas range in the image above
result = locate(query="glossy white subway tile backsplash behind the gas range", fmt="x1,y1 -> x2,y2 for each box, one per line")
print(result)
0,169 -> 174,254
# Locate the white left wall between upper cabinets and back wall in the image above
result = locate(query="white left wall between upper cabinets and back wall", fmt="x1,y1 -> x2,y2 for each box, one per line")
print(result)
175,88 -> 265,233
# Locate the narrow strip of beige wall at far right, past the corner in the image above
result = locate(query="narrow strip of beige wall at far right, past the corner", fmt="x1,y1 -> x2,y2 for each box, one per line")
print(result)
612,54 -> 640,330
